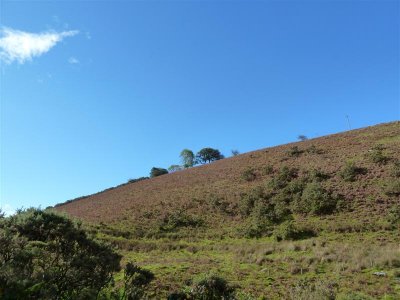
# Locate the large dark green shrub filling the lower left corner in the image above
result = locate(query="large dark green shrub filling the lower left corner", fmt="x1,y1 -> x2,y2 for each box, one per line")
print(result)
0,209 -> 121,299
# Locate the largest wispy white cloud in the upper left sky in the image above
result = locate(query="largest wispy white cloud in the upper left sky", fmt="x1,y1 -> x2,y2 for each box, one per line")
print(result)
0,27 -> 78,64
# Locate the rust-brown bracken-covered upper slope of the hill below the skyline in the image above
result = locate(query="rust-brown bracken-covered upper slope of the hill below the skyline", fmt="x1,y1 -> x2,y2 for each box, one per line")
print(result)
56,122 -> 400,222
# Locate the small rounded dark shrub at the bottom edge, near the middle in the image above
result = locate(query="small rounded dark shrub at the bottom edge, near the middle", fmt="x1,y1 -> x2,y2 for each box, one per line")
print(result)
190,274 -> 235,300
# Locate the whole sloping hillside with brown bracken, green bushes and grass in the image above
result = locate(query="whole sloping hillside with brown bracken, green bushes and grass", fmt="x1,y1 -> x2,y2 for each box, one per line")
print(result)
56,122 -> 400,299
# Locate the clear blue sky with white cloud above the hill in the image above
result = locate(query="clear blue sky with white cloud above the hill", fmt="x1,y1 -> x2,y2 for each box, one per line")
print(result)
0,0 -> 400,214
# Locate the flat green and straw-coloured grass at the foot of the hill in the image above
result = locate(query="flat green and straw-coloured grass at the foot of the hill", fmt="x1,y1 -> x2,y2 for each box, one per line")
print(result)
94,231 -> 400,299
